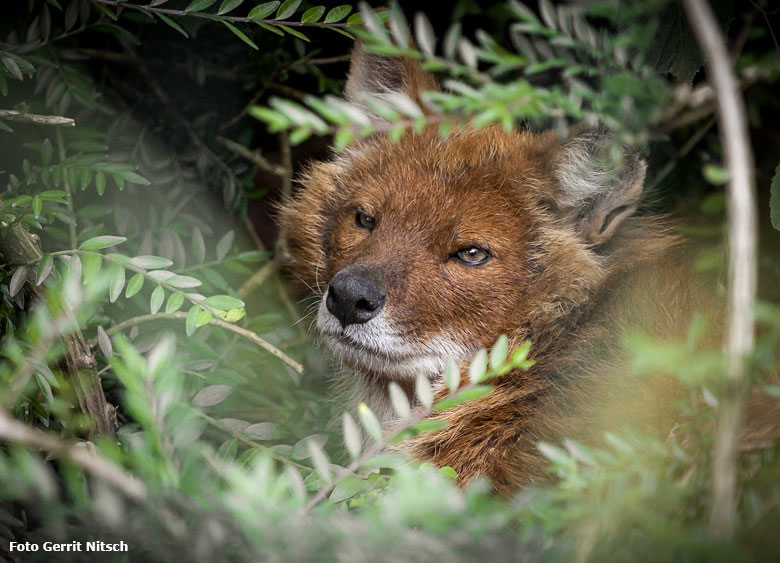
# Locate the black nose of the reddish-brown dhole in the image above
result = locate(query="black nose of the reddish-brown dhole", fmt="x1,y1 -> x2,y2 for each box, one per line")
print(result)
325,270 -> 387,327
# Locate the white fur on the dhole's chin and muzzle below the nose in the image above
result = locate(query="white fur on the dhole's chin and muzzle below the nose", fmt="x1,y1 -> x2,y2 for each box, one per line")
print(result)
317,292 -> 470,379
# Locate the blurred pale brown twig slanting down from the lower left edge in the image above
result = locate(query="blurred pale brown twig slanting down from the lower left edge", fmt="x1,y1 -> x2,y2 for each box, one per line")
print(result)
0,411 -> 147,502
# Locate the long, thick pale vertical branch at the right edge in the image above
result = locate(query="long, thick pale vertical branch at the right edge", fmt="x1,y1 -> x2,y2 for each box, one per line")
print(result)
683,0 -> 757,540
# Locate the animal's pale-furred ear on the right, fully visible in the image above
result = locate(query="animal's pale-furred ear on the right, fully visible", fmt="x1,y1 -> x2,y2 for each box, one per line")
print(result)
555,131 -> 647,245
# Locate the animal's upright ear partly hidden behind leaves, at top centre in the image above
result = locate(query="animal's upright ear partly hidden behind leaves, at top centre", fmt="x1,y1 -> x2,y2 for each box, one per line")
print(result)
345,41 -> 439,115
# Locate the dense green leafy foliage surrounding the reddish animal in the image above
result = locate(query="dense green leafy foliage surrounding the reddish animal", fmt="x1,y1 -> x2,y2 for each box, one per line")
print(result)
0,0 -> 780,561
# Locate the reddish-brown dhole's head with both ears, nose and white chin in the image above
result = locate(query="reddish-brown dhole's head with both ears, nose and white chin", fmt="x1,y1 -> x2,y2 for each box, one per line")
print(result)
279,47 -> 660,380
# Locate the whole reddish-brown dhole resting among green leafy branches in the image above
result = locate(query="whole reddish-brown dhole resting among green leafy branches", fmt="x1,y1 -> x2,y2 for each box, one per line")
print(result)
279,47 -> 720,494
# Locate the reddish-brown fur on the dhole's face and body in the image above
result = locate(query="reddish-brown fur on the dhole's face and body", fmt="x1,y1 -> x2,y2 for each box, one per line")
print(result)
279,50 -> 724,494
